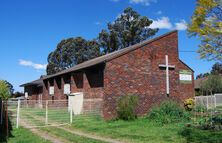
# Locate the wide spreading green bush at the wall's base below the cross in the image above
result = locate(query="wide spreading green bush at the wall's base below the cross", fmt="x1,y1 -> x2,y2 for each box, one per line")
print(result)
148,100 -> 190,124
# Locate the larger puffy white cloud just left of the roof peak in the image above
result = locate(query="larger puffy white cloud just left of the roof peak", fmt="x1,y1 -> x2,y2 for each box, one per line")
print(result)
150,17 -> 173,29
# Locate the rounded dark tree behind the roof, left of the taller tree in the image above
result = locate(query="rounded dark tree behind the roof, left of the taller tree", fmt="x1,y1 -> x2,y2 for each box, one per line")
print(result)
47,37 -> 100,75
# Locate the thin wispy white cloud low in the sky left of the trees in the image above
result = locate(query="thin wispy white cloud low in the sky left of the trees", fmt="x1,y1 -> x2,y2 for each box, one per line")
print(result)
19,59 -> 47,70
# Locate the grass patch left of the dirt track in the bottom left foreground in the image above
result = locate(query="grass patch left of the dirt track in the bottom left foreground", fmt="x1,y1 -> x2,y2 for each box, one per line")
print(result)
8,127 -> 50,143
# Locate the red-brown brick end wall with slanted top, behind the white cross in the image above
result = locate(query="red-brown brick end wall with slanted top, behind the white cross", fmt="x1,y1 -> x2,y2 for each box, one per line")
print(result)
103,32 -> 194,119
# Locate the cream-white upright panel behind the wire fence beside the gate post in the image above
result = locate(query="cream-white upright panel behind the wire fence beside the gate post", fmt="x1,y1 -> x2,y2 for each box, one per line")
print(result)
68,92 -> 83,115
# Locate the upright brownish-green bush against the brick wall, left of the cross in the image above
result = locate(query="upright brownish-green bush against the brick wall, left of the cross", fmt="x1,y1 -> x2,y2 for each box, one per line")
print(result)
117,95 -> 138,120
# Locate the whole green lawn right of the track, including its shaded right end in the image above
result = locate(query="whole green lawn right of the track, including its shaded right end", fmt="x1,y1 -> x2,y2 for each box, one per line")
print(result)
71,117 -> 222,143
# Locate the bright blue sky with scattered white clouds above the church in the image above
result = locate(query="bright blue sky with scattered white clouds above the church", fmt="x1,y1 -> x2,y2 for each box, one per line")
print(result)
0,0 -> 214,91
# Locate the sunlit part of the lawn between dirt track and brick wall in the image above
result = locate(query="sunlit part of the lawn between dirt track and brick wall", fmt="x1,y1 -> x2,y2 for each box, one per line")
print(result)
72,118 -> 186,143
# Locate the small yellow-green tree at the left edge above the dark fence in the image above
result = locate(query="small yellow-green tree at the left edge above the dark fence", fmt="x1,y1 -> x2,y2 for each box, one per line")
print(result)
0,80 -> 10,100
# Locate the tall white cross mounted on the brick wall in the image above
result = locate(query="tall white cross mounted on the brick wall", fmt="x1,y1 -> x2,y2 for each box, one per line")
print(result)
159,55 -> 175,96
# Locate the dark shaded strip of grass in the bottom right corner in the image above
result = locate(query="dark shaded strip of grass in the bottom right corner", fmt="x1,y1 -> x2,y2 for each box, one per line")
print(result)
179,127 -> 222,143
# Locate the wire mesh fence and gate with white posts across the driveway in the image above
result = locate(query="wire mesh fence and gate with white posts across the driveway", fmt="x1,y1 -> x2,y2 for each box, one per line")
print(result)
1,99 -> 102,128
